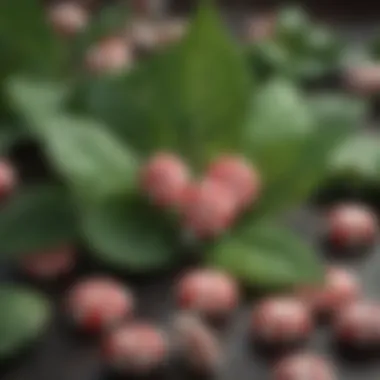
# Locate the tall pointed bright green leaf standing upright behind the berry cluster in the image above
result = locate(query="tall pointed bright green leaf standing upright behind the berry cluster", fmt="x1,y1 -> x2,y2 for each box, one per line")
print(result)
179,1 -> 250,166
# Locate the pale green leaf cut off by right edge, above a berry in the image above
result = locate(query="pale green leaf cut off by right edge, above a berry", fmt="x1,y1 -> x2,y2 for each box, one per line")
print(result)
329,133 -> 380,182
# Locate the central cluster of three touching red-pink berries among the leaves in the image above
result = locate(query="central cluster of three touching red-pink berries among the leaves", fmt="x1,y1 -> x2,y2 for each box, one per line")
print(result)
141,153 -> 261,239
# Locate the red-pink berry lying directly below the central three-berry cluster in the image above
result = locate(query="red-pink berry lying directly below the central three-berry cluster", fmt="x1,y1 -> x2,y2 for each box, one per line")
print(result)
177,269 -> 239,319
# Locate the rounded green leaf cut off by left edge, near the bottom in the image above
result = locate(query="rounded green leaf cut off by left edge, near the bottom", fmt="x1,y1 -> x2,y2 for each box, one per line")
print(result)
0,284 -> 51,359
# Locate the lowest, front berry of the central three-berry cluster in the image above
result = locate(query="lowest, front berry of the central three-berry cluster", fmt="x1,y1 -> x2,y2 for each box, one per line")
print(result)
181,179 -> 237,239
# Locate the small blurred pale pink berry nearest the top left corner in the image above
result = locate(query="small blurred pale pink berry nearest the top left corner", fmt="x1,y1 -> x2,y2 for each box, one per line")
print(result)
48,1 -> 88,36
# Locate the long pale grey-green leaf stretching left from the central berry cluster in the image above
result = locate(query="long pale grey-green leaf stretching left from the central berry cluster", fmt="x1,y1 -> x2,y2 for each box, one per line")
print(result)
8,77 -> 137,202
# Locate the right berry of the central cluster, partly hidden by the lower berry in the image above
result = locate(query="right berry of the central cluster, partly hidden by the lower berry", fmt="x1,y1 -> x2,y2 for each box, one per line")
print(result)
206,156 -> 261,209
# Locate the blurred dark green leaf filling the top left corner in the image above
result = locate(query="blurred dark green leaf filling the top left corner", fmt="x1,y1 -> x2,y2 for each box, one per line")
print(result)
0,0 -> 67,76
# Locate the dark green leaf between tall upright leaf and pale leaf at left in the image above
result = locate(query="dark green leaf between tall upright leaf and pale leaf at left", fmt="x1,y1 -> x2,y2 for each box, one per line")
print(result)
69,51 -> 186,155
